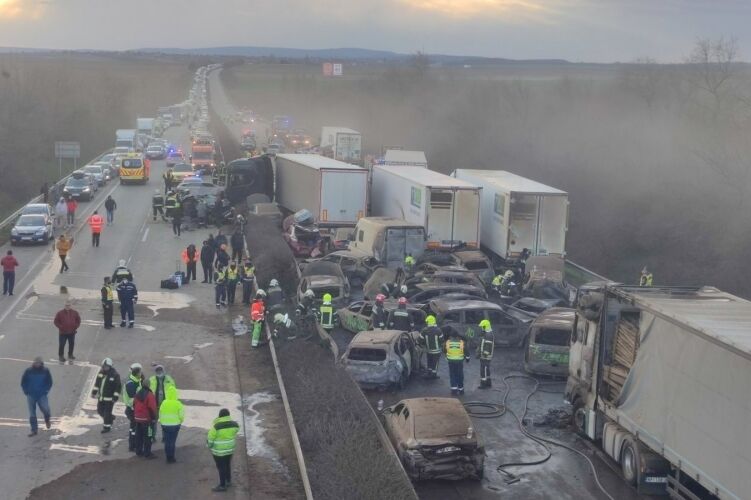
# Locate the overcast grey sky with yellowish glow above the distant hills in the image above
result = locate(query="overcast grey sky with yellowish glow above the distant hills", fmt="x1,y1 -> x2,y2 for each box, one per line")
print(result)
0,0 -> 751,62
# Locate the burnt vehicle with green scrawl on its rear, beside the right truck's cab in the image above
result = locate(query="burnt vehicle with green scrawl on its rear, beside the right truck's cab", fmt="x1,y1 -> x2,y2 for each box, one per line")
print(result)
524,307 -> 575,377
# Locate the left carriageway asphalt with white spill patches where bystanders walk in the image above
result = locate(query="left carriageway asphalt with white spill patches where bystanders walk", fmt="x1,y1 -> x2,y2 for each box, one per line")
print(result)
0,116 -> 294,499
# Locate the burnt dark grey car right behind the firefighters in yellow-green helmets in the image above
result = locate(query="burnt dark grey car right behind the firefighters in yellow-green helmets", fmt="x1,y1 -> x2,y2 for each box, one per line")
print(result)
429,299 -> 534,346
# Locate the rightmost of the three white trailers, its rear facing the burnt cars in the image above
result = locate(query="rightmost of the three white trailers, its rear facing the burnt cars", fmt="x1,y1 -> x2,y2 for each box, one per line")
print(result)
451,169 -> 568,259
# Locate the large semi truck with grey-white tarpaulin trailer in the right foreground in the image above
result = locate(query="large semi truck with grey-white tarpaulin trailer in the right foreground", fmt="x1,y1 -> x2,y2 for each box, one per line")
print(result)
565,282 -> 751,500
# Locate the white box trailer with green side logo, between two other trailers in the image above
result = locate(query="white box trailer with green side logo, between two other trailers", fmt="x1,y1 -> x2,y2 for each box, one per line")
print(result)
371,165 -> 482,248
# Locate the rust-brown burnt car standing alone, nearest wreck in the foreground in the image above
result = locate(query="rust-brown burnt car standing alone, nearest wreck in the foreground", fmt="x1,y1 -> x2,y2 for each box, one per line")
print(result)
382,398 -> 485,481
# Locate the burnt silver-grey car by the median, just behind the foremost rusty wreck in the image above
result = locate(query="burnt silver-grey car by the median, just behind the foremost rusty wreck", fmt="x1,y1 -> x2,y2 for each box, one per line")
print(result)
340,330 -> 422,389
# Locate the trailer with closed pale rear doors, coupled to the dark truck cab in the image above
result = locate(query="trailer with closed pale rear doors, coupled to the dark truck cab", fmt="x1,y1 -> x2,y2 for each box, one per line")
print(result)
274,154 -> 368,226
